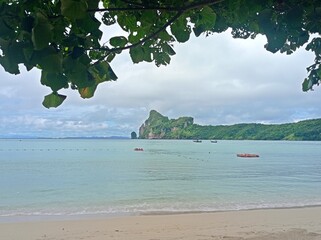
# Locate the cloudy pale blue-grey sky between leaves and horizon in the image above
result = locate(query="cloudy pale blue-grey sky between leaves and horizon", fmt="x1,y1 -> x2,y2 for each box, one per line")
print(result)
0,30 -> 321,137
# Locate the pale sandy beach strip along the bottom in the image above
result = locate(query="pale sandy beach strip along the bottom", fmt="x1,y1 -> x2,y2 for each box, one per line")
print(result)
0,207 -> 321,240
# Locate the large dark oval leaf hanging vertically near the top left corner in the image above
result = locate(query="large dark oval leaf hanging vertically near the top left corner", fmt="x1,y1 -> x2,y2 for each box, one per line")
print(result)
31,13 -> 53,50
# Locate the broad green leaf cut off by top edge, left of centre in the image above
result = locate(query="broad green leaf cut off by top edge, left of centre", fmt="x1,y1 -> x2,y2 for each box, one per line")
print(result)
61,0 -> 88,20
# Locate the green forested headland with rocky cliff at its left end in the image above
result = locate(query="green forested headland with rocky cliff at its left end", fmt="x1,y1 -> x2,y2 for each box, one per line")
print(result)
138,110 -> 321,141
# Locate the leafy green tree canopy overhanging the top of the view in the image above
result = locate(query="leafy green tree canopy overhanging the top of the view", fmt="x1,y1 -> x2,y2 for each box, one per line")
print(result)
0,0 -> 321,108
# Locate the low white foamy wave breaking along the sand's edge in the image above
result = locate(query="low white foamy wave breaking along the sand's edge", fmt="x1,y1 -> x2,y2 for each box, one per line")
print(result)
0,202 -> 321,221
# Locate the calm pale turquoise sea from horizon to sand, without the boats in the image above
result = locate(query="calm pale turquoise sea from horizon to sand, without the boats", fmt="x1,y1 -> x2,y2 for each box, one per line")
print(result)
0,139 -> 321,222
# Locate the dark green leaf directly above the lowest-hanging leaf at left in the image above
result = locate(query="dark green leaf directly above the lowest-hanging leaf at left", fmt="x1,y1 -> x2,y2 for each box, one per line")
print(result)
41,71 -> 68,92
